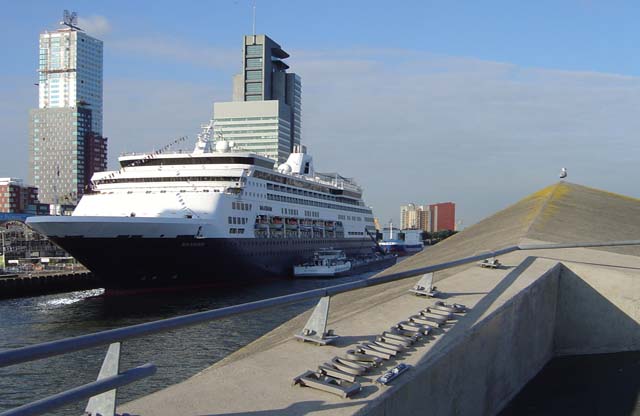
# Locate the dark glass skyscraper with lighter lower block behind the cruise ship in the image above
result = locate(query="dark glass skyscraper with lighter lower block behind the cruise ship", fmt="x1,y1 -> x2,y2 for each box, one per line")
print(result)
213,35 -> 302,163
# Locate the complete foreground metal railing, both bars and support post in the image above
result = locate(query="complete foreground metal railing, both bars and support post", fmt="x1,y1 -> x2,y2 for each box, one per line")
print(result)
0,240 -> 640,416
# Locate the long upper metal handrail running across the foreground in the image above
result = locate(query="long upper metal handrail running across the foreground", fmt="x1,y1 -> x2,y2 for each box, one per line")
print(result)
0,240 -> 640,367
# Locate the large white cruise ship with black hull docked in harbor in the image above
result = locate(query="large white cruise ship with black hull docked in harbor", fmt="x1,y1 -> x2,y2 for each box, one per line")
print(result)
27,135 -> 375,289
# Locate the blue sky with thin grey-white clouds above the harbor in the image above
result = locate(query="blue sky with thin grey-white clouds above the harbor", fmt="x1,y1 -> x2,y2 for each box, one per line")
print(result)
0,0 -> 640,225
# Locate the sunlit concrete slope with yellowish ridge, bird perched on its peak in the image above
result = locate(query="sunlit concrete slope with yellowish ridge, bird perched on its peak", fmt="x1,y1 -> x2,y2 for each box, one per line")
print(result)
381,182 -> 640,280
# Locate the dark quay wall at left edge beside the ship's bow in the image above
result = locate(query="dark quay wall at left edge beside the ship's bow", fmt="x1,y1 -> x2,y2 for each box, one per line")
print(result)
0,270 -> 100,299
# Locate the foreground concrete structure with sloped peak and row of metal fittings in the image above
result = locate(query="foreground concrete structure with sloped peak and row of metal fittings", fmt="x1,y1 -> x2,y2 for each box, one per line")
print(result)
118,182 -> 640,415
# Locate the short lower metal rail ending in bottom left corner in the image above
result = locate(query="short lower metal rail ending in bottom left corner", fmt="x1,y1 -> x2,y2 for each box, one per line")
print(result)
0,363 -> 157,416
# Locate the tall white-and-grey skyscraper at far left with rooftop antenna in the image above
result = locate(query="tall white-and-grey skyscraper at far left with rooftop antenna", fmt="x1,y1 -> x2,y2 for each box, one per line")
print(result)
29,11 -> 107,204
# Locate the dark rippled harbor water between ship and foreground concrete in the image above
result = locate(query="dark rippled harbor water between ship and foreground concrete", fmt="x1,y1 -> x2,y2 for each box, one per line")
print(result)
0,273 -> 373,415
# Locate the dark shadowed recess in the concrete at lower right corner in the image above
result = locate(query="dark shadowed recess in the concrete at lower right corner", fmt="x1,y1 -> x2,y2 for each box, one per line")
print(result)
500,265 -> 640,416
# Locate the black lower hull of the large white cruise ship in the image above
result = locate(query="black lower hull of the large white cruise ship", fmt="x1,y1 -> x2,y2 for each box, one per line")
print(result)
53,237 -> 374,288
